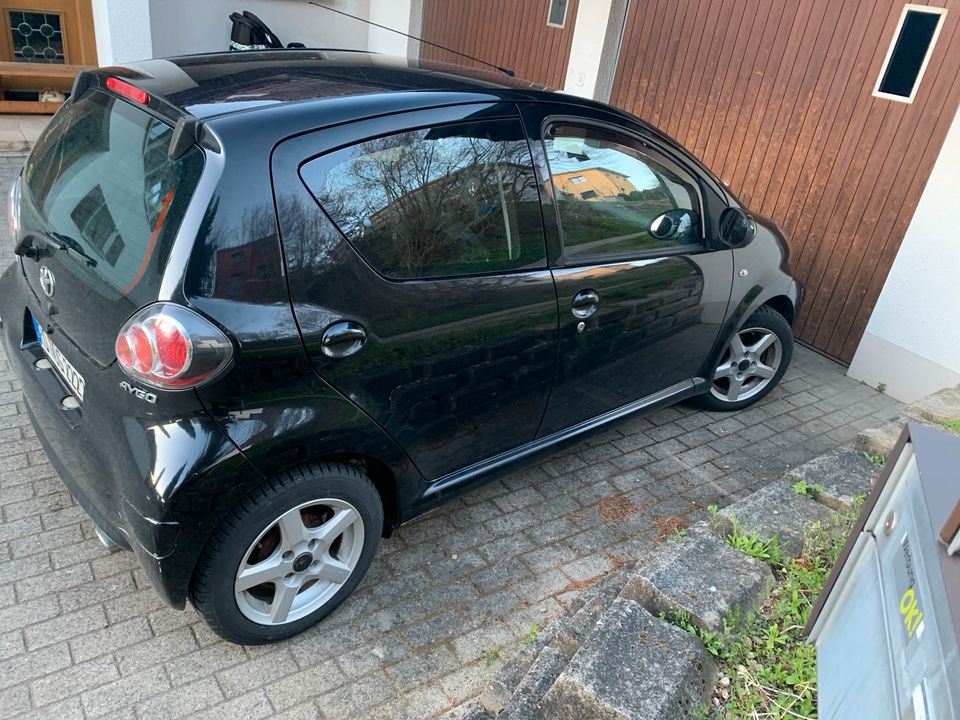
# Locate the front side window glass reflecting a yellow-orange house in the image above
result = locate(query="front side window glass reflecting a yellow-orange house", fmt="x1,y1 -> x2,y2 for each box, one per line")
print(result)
546,126 -> 701,261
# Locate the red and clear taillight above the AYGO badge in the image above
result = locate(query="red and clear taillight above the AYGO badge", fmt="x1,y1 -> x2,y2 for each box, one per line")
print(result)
114,302 -> 233,390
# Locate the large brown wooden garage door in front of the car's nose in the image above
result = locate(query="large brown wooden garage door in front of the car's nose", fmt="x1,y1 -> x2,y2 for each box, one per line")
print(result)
611,0 -> 960,362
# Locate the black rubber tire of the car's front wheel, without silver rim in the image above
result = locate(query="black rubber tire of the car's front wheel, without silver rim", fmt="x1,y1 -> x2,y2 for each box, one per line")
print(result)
697,305 -> 793,411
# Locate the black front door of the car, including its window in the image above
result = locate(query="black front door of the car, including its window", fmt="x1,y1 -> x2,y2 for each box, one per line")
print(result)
524,105 -> 733,436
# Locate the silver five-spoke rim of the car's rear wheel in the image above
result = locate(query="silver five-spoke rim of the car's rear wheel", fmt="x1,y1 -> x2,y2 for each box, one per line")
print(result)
234,498 -> 364,625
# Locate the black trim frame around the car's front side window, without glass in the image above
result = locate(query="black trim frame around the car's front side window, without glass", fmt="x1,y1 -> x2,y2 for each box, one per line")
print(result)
540,115 -> 711,267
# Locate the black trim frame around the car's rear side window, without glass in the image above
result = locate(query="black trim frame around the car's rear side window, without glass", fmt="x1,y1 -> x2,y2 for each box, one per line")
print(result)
293,114 -> 550,283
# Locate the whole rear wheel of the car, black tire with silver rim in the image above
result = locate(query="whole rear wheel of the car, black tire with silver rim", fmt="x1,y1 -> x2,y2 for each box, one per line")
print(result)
190,463 -> 383,645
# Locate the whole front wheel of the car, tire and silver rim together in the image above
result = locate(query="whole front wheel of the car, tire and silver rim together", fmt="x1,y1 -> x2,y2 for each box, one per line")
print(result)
699,305 -> 793,410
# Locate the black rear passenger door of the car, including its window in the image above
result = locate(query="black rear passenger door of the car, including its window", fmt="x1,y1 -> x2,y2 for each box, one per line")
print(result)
273,103 -> 557,479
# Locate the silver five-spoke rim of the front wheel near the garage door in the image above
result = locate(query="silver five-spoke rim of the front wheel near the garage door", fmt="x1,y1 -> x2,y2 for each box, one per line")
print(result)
710,328 -> 783,403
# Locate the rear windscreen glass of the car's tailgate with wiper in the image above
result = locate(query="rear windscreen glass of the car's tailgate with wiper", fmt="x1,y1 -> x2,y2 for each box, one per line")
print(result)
24,92 -> 203,299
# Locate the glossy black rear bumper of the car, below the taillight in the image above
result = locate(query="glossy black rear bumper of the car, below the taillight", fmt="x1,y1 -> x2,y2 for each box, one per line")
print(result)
0,264 -> 246,608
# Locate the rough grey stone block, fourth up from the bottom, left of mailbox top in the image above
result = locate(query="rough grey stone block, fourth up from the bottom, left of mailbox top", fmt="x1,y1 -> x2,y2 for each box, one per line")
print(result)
787,448 -> 880,512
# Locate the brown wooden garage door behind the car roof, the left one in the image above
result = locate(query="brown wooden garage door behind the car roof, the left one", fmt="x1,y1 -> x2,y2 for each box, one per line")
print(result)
420,0 -> 577,88
